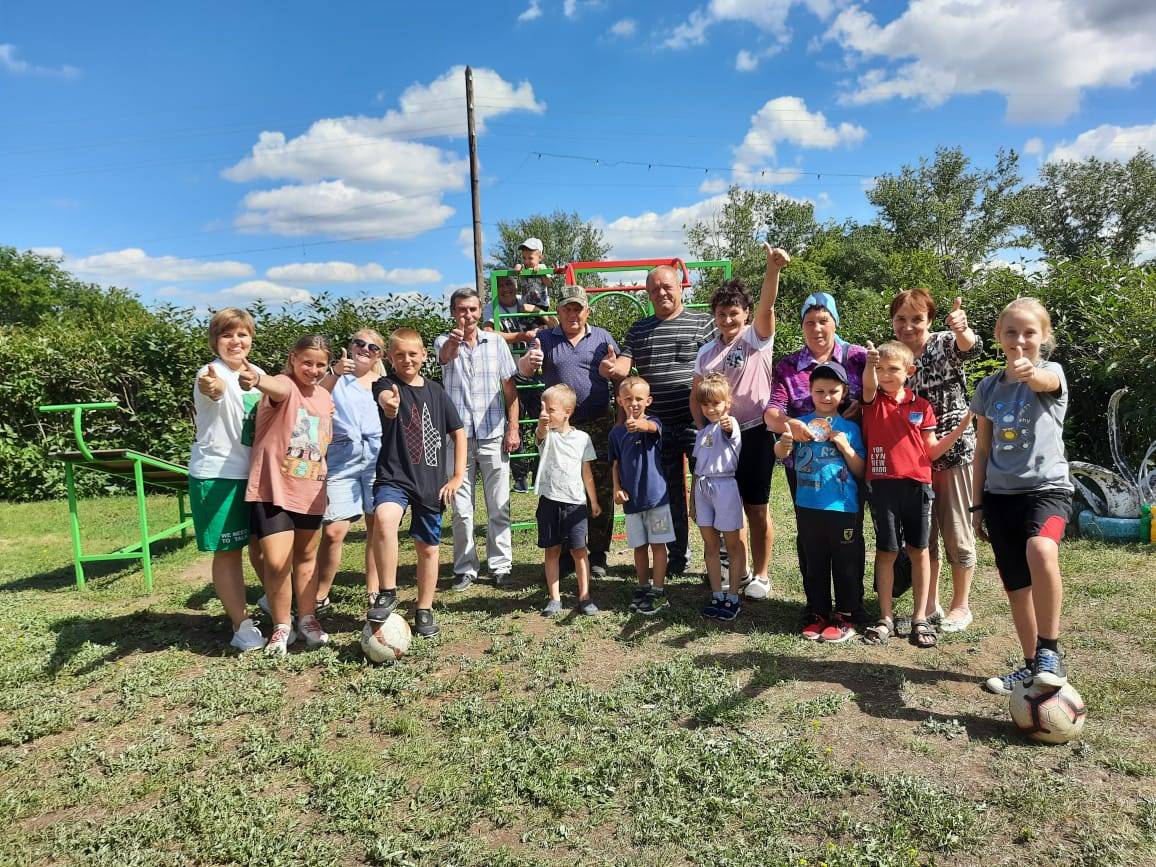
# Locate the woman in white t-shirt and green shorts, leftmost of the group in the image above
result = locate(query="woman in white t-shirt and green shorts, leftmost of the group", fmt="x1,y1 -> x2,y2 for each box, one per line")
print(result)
188,307 -> 265,652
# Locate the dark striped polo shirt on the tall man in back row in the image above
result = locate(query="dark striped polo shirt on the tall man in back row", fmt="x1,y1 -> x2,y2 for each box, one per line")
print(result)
622,309 -> 714,430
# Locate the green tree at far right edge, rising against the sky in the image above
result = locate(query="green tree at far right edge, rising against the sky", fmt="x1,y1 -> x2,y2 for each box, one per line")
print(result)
1020,150 -> 1156,262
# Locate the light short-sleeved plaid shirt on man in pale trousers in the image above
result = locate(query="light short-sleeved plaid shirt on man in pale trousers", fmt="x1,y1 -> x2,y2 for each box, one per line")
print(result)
434,331 -> 517,439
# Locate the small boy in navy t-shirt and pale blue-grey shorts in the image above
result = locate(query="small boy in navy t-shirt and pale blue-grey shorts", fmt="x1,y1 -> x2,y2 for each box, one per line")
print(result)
609,377 -> 674,617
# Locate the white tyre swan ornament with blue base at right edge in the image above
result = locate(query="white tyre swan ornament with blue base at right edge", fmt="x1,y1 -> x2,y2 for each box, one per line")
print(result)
1068,388 -> 1156,542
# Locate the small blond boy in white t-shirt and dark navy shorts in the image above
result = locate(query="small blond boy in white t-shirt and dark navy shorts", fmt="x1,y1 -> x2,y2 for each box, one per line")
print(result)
535,385 -> 602,617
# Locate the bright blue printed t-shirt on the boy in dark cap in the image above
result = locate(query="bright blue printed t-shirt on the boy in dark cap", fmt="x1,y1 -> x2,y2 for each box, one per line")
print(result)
794,413 -> 867,512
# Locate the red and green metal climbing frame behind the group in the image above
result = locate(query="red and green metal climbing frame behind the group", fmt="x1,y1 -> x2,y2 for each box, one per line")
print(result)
490,258 -> 732,529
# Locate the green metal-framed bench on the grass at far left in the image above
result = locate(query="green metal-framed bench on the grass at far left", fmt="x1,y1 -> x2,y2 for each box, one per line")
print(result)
39,403 -> 193,592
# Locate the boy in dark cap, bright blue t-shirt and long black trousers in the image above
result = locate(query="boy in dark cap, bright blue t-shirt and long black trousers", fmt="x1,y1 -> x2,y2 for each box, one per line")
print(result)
775,362 -> 866,644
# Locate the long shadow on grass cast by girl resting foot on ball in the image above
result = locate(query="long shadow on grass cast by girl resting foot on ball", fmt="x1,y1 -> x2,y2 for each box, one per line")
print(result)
695,651 -> 1018,743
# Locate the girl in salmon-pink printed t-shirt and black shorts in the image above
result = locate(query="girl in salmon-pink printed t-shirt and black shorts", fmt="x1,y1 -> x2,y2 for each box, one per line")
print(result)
240,334 -> 333,655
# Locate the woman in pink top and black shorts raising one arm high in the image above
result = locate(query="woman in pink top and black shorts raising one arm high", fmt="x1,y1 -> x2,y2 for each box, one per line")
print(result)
690,242 -> 791,599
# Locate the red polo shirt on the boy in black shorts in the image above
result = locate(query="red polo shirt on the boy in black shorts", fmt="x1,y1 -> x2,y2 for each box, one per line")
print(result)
864,388 -> 935,484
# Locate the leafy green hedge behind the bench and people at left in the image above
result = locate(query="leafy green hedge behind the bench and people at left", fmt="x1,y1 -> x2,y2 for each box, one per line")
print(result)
0,295 -> 451,501
